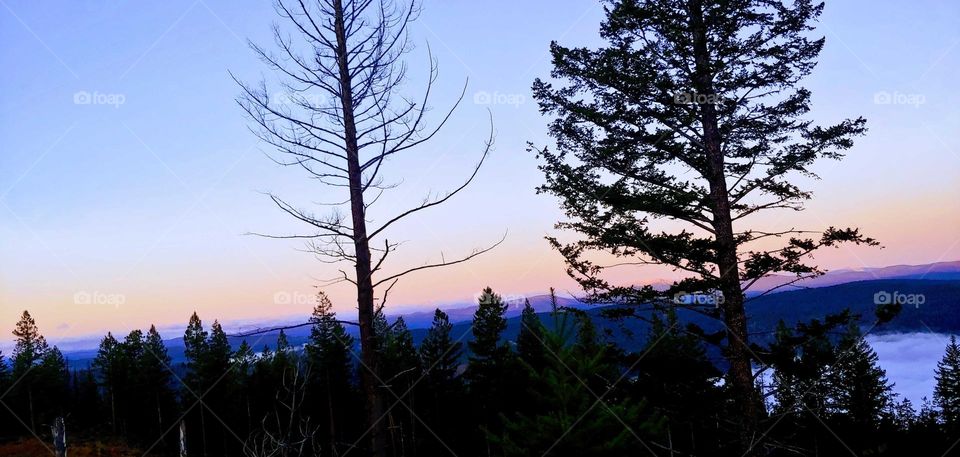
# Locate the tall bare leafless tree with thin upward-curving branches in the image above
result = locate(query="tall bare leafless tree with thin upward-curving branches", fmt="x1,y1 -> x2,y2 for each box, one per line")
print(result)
234,0 -> 503,457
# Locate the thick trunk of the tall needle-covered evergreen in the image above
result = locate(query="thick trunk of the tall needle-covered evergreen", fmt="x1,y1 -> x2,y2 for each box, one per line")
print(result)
690,0 -> 758,451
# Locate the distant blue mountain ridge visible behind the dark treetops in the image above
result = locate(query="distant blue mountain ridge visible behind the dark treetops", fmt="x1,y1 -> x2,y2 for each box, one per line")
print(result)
64,261 -> 960,366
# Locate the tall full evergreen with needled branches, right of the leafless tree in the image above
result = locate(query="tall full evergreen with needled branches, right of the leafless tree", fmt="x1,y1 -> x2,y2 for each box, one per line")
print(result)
533,0 -> 874,450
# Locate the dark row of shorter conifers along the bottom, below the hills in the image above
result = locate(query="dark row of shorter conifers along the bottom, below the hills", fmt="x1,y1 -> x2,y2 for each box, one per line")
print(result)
0,288 -> 960,457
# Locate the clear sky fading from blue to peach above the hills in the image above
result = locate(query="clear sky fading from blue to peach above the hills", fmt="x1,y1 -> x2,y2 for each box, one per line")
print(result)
0,0 -> 960,342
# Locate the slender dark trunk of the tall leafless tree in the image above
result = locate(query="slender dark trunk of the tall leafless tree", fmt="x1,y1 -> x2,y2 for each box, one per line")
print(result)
333,0 -> 387,457
